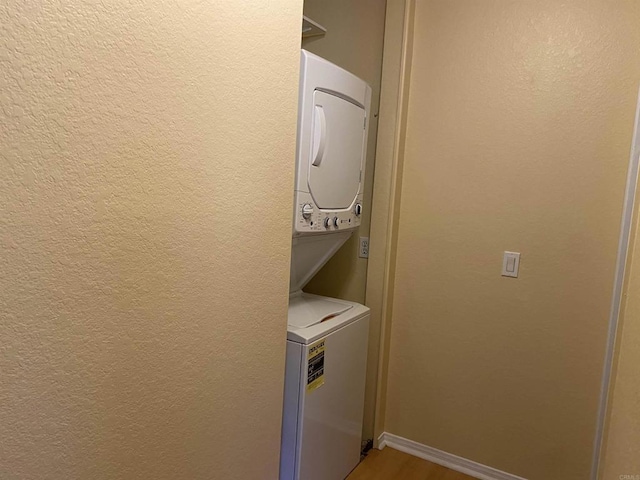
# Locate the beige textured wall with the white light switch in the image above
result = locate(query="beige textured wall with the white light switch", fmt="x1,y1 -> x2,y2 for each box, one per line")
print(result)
385,0 -> 640,480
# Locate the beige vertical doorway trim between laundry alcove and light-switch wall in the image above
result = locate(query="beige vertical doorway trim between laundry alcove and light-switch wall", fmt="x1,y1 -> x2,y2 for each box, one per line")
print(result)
366,0 -> 415,446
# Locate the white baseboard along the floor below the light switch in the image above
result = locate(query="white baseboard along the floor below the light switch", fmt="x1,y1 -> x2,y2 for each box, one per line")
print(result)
378,432 -> 526,480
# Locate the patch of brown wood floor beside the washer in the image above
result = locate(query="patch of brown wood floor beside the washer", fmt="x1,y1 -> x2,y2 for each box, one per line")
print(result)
347,447 -> 476,480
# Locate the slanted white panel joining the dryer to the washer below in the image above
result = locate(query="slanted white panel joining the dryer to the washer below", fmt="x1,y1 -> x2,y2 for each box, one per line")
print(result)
289,231 -> 352,293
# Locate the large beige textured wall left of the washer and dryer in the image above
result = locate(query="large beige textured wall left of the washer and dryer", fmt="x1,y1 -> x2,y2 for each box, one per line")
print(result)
0,0 -> 302,480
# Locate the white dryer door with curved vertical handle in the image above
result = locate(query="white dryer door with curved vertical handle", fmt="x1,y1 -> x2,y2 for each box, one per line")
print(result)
308,90 -> 365,210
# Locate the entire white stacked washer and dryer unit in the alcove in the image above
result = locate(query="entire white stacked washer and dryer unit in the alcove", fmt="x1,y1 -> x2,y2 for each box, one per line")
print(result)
280,50 -> 371,480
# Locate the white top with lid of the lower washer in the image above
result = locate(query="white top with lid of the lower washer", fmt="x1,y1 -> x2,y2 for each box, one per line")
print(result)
287,293 -> 370,345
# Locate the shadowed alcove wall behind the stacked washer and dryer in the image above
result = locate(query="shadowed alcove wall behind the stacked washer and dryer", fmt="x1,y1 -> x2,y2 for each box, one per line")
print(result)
302,0 -> 386,439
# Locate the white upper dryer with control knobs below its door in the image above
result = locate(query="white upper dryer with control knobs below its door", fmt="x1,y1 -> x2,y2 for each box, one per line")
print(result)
293,50 -> 371,236
